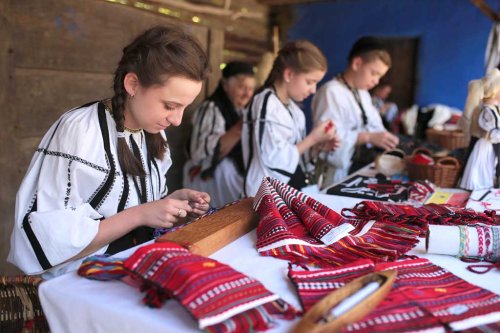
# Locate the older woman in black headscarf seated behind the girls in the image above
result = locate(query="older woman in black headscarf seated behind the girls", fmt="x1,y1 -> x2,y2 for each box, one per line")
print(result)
184,61 -> 255,207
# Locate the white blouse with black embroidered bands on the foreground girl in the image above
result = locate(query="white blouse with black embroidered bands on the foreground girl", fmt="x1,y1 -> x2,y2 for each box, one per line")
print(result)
8,102 -> 172,274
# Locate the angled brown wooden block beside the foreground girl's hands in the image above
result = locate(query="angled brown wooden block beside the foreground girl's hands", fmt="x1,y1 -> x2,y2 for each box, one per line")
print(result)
156,198 -> 258,256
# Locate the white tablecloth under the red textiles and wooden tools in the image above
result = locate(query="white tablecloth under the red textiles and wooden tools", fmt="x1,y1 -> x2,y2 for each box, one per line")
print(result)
39,194 -> 500,333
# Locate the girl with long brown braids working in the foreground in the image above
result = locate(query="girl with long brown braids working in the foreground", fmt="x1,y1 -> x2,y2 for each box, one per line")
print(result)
8,27 -> 210,277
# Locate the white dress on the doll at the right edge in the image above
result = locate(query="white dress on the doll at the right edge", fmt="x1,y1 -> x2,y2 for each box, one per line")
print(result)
460,104 -> 500,190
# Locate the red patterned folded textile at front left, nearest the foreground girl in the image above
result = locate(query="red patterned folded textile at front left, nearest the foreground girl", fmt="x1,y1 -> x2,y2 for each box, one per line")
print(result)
79,242 -> 299,333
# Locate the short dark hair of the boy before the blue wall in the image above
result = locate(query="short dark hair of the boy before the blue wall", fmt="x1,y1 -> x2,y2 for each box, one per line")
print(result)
347,36 -> 392,67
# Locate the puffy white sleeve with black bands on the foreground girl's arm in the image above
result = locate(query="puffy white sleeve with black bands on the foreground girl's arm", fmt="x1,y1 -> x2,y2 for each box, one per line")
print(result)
8,110 -> 108,274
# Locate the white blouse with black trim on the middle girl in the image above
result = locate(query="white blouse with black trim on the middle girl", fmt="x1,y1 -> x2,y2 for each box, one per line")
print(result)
241,88 -> 307,196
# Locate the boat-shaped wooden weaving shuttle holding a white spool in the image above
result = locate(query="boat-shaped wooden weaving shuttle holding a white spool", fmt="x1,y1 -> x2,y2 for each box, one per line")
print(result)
293,270 -> 397,333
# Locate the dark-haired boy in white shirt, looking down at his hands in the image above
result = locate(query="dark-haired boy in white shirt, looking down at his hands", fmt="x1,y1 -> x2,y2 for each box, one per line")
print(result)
312,37 -> 399,186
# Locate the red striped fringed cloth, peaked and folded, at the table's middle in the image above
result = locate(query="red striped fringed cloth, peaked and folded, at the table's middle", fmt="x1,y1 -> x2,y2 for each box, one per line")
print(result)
254,177 -> 425,267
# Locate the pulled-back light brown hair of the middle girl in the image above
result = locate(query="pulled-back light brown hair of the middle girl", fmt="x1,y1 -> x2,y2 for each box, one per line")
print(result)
264,40 -> 328,88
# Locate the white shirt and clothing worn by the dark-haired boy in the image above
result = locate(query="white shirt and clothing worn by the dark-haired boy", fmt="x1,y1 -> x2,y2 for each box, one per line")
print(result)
312,76 -> 385,185
